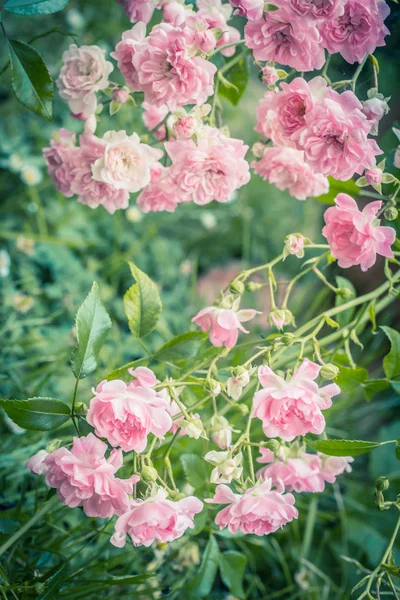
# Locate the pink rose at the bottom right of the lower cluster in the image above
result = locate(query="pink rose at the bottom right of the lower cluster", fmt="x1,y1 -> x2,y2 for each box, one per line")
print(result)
206,479 -> 298,536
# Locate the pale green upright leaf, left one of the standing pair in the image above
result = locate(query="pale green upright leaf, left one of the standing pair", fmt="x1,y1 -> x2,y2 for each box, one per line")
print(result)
71,282 -> 111,379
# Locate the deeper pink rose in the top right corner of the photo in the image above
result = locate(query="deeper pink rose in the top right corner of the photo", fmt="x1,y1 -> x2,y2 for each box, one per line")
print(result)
320,0 -> 390,63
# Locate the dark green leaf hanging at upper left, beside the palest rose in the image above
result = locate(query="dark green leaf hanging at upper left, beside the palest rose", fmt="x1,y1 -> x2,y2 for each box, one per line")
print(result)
8,40 -> 54,121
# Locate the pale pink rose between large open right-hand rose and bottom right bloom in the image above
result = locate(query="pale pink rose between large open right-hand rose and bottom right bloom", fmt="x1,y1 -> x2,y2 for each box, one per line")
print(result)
257,448 -> 325,492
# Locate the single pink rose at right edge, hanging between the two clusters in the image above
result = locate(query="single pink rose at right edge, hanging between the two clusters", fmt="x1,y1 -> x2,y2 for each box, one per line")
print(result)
322,194 -> 396,271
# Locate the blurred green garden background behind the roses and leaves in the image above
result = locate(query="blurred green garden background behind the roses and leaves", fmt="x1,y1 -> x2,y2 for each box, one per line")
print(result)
0,0 -> 400,600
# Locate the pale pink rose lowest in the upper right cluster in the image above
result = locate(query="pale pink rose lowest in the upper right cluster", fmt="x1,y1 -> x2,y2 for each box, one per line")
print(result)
251,146 -> 329,200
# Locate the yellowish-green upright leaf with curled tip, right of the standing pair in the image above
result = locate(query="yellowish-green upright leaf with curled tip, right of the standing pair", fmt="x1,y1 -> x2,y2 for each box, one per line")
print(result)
124,262 -> 162,338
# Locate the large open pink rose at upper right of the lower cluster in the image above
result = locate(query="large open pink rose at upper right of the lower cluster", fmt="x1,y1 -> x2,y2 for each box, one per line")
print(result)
253,359 -> 340,442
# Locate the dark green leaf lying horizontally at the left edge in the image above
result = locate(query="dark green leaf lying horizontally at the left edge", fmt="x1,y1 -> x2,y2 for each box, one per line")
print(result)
0,398 -> 71,431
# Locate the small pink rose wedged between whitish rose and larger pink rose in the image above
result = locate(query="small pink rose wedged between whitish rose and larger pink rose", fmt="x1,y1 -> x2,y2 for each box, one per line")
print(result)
136,163 -> 189,213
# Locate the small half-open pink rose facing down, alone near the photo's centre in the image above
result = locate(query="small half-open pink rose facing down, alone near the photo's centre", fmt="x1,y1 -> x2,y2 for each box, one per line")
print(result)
192,306 -> 259,348
